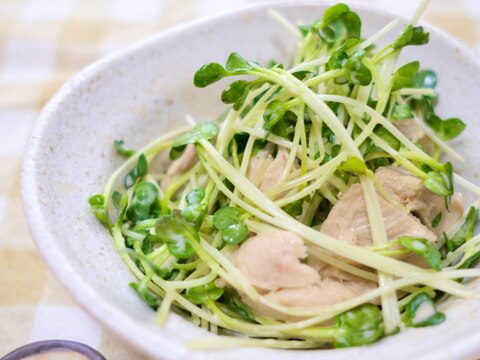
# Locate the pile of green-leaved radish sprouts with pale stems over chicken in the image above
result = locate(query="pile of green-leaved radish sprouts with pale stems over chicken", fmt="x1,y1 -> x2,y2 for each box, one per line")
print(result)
89,1 -> 480,349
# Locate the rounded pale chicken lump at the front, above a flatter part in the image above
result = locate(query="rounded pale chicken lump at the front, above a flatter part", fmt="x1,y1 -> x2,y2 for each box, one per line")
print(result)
233,231 -> 320,291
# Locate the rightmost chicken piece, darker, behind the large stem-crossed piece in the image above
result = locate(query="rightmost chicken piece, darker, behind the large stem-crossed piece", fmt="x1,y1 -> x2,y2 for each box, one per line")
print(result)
375,166 -> 463,235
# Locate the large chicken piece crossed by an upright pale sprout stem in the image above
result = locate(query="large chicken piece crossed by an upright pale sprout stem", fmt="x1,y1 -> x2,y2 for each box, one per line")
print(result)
320,184 -> 437,246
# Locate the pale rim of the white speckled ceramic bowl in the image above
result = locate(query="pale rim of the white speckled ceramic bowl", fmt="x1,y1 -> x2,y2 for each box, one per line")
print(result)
21,0 -> 480,360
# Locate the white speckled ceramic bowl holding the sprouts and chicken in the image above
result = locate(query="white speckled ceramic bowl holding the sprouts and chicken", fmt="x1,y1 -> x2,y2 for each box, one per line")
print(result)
22,1 -> 480,360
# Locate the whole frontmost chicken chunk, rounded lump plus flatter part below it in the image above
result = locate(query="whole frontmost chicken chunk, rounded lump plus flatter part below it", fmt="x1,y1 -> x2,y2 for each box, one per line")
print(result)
233,231 -> 376,321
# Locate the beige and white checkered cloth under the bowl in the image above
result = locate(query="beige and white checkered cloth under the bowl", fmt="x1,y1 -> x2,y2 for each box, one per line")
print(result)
0,0 -> 480,360
